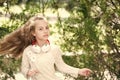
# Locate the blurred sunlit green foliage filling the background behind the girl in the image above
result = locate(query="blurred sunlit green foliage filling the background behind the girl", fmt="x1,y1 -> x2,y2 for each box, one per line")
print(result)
0,0 -> 120,80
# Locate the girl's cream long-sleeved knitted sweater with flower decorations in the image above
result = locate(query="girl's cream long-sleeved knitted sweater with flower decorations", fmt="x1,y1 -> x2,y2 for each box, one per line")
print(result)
21,45 -> 79,80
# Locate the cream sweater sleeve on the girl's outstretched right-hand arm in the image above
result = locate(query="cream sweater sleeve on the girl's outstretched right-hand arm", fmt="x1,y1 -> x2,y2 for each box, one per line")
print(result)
55,47 -> 79,78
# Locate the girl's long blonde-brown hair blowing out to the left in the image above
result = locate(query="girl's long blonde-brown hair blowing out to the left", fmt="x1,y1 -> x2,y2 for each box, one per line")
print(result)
0,15 -> 45,57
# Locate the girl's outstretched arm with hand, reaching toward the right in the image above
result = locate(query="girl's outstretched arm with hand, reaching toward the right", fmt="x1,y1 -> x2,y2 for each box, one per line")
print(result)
55,48 -> 92,77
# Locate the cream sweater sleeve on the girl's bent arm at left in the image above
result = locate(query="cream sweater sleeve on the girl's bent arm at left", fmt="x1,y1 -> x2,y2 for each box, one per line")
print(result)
21,49 -> 30,78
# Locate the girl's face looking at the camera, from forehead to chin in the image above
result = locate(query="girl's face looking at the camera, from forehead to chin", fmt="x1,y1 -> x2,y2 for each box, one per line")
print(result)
33,20 -> 50,41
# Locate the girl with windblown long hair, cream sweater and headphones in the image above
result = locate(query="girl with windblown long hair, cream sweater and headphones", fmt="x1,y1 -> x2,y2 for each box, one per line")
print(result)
0,15 -> 91,80
